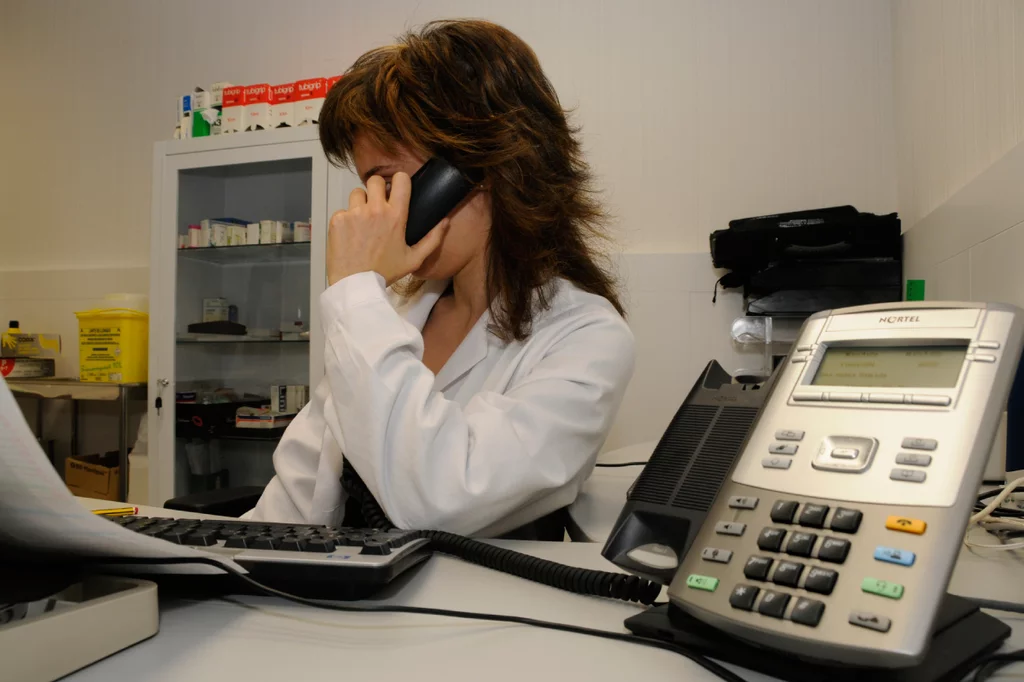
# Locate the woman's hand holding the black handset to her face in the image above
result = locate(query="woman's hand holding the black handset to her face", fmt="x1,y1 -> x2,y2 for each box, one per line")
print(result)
327,173 -> 449,286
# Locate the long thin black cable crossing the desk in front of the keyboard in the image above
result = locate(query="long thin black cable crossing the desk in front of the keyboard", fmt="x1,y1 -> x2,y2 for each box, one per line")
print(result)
88,556 -> 748,682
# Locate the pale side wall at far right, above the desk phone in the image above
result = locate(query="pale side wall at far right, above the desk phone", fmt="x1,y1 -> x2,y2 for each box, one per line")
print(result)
893,0 -> 1024,305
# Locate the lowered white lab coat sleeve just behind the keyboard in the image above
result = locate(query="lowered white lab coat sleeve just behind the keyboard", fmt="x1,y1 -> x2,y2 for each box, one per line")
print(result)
243,379 -> 345,525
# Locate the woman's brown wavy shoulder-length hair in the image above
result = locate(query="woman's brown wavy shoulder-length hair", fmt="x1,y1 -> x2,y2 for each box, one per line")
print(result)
319,20 -> 625,341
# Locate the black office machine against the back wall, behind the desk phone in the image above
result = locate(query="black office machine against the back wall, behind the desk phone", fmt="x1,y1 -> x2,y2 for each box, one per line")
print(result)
711,206 -> 903,317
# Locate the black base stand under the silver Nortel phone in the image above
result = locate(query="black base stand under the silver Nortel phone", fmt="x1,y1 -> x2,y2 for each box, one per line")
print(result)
626,594 -> 1010,682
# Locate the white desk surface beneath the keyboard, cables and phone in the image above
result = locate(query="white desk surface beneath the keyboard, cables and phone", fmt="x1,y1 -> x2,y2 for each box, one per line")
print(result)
67,501 -> 1024,682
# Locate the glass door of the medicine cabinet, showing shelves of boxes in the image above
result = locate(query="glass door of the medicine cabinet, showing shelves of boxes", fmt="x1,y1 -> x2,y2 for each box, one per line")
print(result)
168,158 -> 313,496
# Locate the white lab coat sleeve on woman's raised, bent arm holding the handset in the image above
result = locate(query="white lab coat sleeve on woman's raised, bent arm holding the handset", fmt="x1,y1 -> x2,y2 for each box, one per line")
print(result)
321,272 -> 634,535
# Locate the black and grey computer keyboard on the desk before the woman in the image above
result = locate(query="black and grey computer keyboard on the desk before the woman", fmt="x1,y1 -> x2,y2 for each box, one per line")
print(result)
111,516 -> 430,599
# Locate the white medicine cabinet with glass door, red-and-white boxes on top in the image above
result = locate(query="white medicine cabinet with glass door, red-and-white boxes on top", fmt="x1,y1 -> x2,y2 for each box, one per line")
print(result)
147,126 -> 358,506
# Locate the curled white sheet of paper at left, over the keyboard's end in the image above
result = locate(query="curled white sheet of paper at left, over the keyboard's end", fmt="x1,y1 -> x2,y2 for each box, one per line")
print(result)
0,380 -> 238,573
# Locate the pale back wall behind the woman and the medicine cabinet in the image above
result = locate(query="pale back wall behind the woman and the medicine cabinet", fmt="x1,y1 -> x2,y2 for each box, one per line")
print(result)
0,0 -> 896,450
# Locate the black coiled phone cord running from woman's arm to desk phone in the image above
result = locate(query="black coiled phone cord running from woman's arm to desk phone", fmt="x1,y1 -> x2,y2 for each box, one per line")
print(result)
341,462 -> 662,606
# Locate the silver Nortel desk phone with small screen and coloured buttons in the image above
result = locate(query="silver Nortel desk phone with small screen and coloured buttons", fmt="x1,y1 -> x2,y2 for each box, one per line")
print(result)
605,303 -> 1024,668
